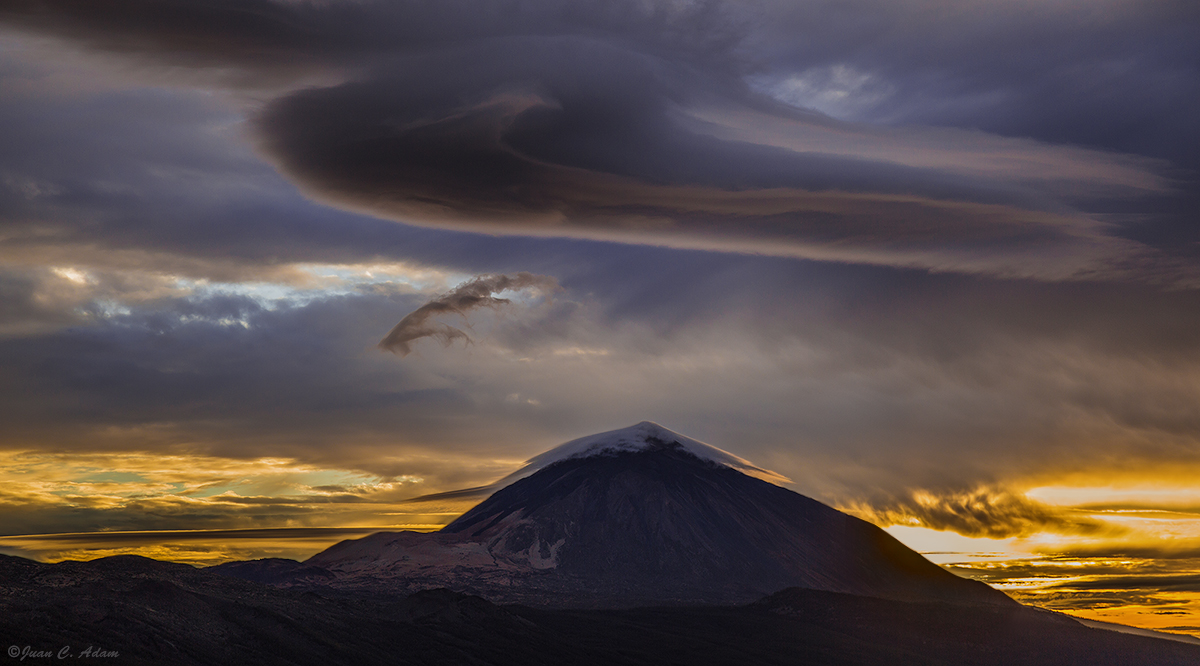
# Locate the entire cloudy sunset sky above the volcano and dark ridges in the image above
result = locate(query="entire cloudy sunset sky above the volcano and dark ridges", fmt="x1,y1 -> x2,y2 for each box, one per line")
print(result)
0,0 -> 1200,632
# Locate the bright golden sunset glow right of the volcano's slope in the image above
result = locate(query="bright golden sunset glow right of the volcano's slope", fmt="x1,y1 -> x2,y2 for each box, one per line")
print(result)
886,481 -> 1200,637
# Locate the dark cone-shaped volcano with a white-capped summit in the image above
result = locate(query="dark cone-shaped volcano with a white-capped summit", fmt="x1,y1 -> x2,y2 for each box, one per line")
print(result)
296,421 -> 1013,607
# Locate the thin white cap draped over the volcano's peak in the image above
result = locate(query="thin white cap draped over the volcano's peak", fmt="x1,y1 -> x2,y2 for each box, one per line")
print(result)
493,421 -> 790,488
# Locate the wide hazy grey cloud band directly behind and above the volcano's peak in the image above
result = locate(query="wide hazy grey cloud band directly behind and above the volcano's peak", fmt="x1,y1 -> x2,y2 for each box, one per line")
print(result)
0,255 -> 1200,489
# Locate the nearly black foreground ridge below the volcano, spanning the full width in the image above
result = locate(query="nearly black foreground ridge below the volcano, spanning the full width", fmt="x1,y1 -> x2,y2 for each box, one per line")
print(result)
0,556 -> 1200,666
